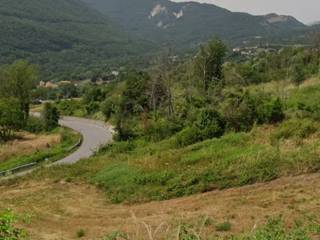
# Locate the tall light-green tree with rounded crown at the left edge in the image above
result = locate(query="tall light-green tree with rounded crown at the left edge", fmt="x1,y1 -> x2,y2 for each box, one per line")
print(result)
0,60 -> 38,123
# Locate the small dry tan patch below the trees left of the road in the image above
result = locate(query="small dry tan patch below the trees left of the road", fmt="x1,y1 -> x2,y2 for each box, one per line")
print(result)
0,133 -> 61,162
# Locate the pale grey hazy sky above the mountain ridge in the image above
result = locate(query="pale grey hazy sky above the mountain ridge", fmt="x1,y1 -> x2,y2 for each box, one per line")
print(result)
173,0 -> 320,24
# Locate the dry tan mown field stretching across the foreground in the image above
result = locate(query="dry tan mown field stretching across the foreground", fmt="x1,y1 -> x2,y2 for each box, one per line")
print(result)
0,174 -> 320,240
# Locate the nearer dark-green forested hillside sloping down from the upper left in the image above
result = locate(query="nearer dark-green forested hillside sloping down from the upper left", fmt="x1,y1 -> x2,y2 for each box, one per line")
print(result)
0,0 -> 156,79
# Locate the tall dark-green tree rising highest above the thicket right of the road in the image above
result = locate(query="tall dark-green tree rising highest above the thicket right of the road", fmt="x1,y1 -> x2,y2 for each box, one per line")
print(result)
194,40 -> 227,91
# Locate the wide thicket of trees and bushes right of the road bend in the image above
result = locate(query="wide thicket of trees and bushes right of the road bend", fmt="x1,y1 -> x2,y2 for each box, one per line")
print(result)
65,40 -> 320,146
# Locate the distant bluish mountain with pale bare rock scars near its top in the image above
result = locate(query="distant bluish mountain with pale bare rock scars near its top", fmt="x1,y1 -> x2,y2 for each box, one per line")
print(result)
83,0 -> 306,47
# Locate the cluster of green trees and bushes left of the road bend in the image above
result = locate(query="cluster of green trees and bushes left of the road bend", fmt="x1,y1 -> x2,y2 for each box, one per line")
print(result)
0,60 -> 59,141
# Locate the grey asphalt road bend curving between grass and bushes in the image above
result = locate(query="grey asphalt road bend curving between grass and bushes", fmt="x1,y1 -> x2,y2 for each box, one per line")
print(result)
52,117 -> 113,165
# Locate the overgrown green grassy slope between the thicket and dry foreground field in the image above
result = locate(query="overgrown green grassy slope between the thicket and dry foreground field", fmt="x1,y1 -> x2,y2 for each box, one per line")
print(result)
23,119 -> 320,203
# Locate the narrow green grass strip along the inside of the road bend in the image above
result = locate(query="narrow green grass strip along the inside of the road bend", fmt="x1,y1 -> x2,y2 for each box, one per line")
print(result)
0,128 -> 80,171
